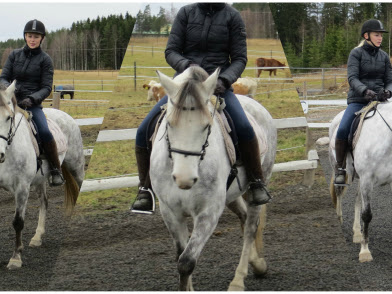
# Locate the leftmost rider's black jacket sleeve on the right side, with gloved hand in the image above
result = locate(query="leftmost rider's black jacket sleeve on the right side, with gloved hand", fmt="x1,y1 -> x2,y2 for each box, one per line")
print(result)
28,55 -> 54,104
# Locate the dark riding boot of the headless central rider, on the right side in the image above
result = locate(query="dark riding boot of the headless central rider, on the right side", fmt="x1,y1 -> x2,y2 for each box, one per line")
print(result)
239,136 -> 271,206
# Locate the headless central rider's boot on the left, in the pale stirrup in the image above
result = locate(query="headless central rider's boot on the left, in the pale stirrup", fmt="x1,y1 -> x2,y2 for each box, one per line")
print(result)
131,145 -> 155,214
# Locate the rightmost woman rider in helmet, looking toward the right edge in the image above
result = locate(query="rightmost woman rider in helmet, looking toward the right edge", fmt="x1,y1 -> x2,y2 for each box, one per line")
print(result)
335,19 -> 392,184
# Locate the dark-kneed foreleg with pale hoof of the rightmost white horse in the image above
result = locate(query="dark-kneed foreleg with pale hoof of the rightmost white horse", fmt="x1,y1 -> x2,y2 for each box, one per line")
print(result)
359,182 -> 373,262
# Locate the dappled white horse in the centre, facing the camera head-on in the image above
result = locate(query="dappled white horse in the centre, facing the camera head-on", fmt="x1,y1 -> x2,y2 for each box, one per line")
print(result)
150,67 -> 277,290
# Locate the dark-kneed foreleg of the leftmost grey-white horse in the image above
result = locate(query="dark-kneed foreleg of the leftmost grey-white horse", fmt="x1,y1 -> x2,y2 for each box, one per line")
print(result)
7,189 -> 29,269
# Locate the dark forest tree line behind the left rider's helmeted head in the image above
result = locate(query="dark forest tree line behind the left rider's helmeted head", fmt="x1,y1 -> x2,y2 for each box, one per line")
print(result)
0,12 -> 135,70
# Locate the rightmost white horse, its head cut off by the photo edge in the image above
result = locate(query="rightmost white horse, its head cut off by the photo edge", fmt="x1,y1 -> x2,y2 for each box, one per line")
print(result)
329,103 -> 392,262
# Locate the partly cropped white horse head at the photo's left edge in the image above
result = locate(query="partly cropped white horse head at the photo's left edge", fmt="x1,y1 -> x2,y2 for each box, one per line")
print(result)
0,81 -> 16,163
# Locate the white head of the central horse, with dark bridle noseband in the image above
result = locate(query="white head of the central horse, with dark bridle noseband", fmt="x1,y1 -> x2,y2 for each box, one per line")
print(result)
157,66 -> 220,190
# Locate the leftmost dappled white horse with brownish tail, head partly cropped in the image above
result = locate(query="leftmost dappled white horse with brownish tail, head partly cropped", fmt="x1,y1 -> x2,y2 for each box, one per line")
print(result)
0,82 -> 84,269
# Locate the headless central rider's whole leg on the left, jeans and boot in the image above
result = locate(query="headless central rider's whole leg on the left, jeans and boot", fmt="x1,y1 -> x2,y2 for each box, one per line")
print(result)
131,96 -> 167,212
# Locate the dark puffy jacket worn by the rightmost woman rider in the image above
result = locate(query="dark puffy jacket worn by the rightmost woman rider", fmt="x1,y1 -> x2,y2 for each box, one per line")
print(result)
347,42 -> 392,104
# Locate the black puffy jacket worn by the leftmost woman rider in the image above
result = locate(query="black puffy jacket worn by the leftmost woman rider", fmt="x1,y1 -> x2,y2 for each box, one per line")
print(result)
0,45 -> 54,105
